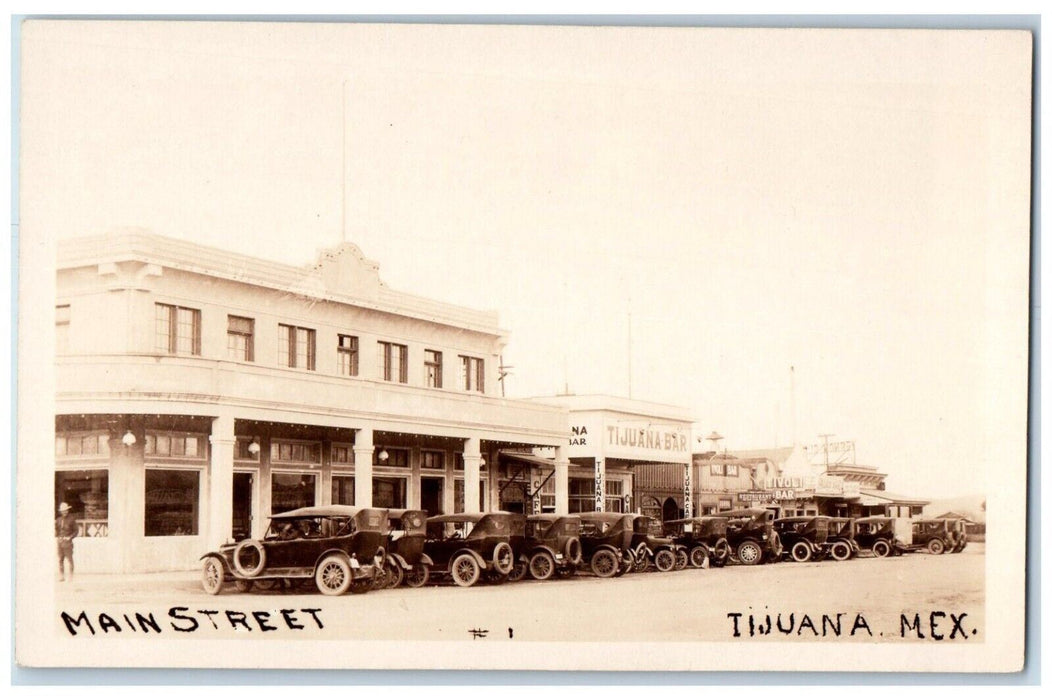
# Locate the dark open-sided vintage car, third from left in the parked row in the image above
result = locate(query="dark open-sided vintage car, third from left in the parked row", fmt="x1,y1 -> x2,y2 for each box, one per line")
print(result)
424,512 -> 523,586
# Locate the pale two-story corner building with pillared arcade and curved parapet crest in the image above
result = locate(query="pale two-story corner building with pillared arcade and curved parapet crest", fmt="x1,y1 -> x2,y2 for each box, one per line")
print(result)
55,232 -> 569,572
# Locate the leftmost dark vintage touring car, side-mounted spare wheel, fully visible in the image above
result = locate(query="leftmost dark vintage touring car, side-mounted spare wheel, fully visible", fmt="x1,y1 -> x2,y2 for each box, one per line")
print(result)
201,505 -> 387,596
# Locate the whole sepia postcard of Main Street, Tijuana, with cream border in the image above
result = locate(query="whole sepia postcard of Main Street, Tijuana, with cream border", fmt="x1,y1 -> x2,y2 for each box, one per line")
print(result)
15,19 -> 1034,673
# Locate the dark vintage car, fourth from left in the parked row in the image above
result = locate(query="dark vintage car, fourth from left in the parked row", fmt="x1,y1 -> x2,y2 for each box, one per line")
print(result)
509,514 -> 581,581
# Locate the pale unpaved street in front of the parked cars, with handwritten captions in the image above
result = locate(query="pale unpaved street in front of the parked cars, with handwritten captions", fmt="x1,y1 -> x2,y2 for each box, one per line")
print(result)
55,544 -> 986,642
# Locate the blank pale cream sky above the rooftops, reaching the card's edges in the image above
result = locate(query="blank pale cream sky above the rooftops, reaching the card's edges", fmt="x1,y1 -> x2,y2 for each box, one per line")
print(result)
20,22 -> 1030,497
